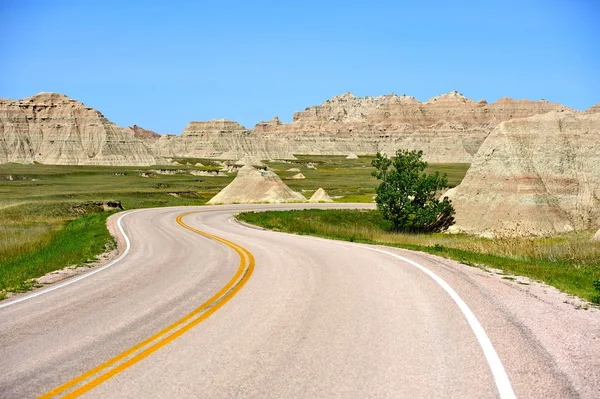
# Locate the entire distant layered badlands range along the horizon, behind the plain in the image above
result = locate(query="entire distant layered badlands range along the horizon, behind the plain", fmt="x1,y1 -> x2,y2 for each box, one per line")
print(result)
0,91 -> 580,165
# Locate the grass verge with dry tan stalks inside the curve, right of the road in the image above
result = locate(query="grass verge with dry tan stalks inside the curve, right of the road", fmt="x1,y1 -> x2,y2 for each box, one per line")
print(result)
238,210 -> 600,302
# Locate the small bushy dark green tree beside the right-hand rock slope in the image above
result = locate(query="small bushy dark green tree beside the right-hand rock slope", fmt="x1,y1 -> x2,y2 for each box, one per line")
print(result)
371,149 -> 454,232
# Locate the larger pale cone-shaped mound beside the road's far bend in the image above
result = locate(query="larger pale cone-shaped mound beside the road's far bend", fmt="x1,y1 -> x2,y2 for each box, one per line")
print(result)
208,165 -> 306,204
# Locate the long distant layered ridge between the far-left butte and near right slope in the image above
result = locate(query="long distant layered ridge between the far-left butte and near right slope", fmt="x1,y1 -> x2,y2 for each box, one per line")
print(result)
153,91 -> 566,163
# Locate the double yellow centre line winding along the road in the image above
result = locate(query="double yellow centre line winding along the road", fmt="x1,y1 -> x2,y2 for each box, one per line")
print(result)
40,211 -> 254,398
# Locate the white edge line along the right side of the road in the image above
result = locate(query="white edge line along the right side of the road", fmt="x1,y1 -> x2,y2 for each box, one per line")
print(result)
229,217 -> 516,399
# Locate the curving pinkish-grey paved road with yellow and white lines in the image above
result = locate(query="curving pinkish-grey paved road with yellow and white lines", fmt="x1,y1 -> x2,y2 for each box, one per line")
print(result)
0,204 -> 600,398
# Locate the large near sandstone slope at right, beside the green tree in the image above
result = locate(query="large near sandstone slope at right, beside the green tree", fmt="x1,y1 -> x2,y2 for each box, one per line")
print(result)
451,112 -> 600,236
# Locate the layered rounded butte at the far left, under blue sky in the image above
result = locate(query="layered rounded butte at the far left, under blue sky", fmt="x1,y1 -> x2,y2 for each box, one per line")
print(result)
0,93 -> 161,166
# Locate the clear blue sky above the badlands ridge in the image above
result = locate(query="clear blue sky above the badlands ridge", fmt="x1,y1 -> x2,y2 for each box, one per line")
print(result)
0,0 -> 600,134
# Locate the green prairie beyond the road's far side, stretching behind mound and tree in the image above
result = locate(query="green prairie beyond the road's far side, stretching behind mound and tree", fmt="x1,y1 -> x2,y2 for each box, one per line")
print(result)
0,155 -> 468,297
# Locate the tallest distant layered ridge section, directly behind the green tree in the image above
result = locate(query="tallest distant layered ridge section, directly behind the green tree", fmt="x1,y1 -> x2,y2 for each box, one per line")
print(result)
250,92 -> 564,162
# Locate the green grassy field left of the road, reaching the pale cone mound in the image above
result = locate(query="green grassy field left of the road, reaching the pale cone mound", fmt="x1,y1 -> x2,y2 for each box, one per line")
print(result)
0,161 -> 233,296
